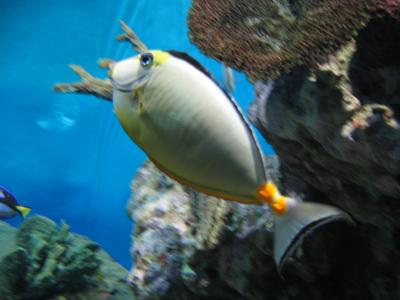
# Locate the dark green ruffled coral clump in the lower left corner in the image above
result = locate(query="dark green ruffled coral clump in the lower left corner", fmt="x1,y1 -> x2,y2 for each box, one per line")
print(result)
0,217 -> 101,299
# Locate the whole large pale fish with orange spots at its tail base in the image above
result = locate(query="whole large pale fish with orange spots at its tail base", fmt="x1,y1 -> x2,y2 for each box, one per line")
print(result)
110,50 -> 348,269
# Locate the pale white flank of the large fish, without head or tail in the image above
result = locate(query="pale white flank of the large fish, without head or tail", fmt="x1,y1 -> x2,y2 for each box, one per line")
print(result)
114,57 -> 266,204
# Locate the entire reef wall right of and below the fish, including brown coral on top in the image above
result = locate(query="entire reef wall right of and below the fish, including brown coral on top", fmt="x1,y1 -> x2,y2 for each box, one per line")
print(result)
125,0 -> 400,300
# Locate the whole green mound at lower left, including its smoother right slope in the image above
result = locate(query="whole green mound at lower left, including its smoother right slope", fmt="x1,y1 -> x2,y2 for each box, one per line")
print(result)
0,216 -> 134,300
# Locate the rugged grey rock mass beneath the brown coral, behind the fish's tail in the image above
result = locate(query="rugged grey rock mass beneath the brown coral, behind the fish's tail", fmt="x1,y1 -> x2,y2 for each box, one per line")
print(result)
125,5 -> 400,300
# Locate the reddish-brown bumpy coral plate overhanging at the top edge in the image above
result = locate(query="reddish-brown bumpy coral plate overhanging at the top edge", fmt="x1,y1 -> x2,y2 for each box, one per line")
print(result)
188,0 -> 376,79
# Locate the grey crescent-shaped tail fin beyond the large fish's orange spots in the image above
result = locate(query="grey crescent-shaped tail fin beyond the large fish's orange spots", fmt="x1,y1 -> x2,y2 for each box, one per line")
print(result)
274,202 -> 351,272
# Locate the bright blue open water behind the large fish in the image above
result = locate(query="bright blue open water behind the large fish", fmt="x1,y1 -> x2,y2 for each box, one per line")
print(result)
0,0 -> 272,267
